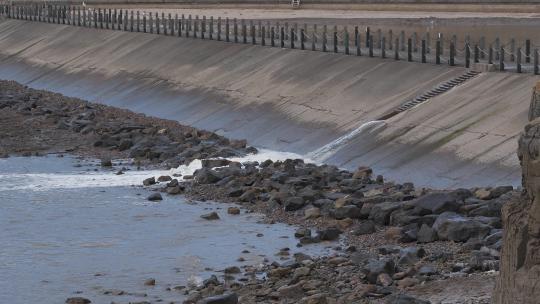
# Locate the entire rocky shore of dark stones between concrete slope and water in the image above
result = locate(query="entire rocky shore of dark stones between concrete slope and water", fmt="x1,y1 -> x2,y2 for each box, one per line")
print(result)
0,82 -> 516,303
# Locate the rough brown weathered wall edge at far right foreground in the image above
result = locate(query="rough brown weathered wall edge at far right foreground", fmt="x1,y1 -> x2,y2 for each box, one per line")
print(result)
493,84 -> 540,304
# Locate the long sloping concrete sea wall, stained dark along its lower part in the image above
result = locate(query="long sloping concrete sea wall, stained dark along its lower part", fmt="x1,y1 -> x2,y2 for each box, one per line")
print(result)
0,20 -> 537,187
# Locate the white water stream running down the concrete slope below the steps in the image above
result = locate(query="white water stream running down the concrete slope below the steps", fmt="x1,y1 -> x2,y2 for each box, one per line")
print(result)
306,120 -> 386,162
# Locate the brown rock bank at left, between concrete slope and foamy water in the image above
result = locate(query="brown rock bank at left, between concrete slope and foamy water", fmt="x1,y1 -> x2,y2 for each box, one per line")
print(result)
0,81 -> 257,168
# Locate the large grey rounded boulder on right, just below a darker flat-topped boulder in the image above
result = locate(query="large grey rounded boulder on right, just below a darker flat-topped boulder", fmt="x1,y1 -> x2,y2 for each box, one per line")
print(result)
433,212 -> 491,242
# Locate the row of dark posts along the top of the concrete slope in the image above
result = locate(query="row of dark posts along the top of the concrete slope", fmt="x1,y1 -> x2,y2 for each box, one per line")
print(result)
0,5 -> 539,74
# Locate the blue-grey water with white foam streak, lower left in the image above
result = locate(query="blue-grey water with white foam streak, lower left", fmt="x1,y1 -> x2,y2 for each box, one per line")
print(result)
0,156 -> 331,304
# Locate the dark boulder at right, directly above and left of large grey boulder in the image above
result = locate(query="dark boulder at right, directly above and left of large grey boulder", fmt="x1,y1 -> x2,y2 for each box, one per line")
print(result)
411,192 -> 461,215
